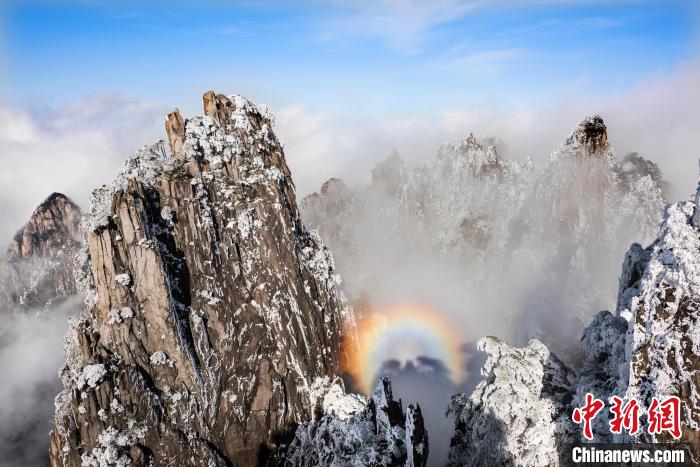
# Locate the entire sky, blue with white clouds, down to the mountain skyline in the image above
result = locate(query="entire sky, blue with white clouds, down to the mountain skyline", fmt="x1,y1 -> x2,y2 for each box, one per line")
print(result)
0,0 -> 700,244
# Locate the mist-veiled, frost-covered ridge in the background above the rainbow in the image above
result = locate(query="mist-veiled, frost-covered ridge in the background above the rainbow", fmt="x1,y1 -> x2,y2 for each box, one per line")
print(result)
301,116 -> 665,362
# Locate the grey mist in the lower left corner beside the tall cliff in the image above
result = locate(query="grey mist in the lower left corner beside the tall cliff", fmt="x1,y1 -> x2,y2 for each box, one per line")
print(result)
0,297 -> 80,467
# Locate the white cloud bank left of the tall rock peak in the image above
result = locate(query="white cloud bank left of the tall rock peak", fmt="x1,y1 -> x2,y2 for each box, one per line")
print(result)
0,96 -> 166,245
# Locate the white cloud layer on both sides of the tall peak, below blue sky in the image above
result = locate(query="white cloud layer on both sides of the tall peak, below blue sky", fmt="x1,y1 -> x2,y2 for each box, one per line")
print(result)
0,61 -> 700,245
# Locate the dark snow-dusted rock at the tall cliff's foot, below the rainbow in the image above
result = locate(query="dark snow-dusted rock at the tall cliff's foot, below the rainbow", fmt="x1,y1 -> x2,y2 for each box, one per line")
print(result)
277,379 -> 429,467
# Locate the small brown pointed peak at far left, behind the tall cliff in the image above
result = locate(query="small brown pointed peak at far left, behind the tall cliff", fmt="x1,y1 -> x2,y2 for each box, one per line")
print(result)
0,193 -> 81,310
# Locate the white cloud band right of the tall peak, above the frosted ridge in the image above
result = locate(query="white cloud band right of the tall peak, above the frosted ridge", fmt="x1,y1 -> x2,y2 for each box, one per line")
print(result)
276,61 -> 700,203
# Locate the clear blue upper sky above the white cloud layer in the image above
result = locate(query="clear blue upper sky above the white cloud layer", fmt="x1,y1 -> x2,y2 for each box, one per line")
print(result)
4,0 -> 698,115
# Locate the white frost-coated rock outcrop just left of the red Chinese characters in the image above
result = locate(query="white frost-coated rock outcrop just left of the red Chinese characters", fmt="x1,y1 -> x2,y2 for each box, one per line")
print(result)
449,337 -> 575,467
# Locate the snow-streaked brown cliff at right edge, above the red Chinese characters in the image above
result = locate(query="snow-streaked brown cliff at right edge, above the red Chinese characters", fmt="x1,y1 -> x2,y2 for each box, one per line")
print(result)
578,195 -> 700,446
